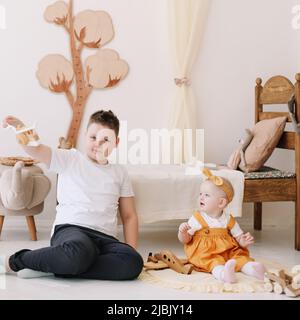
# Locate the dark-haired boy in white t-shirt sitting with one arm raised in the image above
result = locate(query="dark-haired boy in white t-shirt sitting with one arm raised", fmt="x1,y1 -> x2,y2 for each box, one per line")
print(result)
0,110 -> 143,280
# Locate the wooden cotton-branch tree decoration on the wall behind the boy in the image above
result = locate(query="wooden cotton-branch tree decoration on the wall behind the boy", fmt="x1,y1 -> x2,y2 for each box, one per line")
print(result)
37,0 -> 129,149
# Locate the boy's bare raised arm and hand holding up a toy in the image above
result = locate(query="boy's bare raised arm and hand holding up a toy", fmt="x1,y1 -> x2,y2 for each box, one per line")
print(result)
2,116 -> 52,168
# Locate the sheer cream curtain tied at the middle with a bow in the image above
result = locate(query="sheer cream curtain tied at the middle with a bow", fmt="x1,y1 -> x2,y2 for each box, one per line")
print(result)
168,0 -> 210,163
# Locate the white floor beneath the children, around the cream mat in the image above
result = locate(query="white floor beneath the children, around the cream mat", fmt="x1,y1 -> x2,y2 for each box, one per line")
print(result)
0,223 -> 300,300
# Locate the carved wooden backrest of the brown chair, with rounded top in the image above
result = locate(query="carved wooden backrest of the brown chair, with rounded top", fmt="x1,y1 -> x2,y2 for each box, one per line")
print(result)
255,73 -> 300,152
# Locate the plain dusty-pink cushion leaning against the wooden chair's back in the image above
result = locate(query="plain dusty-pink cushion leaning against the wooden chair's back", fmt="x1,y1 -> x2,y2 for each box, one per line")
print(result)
240,117 -> 287,173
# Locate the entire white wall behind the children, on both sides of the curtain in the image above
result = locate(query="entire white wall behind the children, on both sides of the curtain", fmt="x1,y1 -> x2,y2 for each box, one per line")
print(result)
0,0 -> 300,230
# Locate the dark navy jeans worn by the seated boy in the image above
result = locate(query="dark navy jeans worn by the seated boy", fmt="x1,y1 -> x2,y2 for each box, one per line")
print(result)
9,224 -> 143,280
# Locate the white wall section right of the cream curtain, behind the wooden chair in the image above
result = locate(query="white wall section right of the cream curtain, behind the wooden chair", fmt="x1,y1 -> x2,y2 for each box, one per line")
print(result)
194,0 -> 300,228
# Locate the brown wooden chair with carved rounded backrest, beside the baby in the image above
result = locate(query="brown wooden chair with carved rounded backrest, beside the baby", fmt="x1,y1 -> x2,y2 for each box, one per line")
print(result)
244,73 -> 300,250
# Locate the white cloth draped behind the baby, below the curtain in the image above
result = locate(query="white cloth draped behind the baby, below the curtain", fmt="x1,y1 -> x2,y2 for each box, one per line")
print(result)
127,165 -> 244,223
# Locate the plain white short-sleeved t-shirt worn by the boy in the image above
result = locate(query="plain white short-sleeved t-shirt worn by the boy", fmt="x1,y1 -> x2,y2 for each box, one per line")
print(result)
49,149 -> 134,237
